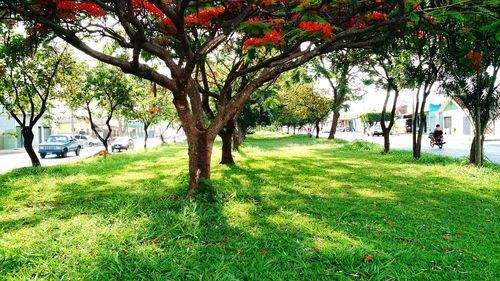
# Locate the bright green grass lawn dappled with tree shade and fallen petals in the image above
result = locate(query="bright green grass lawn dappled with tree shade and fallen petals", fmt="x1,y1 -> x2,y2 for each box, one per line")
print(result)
0,135 -> 500,280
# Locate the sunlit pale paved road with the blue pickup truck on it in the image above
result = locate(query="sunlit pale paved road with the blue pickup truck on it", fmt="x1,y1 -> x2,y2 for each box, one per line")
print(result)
0,134 -> 185,174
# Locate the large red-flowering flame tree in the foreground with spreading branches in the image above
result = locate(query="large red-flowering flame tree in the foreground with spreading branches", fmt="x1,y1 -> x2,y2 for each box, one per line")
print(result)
0,0 -> 405,195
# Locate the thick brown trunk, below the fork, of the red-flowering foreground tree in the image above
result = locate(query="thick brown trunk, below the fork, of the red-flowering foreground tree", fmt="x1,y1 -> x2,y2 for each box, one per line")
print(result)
187,130 -> 214,197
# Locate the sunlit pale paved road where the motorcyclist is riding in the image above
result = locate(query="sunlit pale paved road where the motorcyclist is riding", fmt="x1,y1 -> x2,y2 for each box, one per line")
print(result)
321,133 -> 500,164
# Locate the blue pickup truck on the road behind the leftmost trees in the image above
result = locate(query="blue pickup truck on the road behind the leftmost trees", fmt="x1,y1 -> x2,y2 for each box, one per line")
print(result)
38,135 -> 83,159
